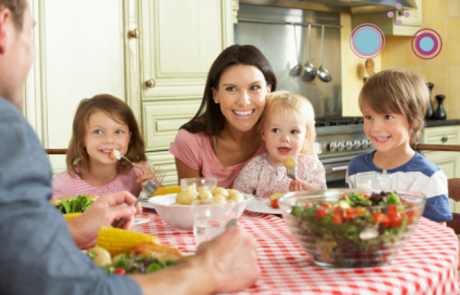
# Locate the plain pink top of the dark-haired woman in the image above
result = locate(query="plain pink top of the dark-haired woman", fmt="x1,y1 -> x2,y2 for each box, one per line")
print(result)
169,129 -> 265,188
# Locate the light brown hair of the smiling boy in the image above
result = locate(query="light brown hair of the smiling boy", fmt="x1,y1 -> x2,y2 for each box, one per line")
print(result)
359,70 -> 430,143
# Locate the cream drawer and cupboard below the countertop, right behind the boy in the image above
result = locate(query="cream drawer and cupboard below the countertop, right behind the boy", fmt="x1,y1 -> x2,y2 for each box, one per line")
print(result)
423,125 -> 460,178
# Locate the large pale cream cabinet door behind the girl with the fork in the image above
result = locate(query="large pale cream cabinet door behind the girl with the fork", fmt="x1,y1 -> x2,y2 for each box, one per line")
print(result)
25,0 -> 129,173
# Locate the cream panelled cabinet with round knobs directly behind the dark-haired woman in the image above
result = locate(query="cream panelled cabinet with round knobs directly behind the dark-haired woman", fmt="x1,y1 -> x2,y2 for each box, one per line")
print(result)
139,0 -> 234,151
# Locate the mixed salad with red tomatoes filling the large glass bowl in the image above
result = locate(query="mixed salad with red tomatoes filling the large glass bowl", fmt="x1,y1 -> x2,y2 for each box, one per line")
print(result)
291,191 -> 420,266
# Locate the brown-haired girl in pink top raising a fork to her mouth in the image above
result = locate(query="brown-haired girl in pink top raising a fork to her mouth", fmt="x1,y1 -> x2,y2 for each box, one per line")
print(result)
52,94 -> 153,199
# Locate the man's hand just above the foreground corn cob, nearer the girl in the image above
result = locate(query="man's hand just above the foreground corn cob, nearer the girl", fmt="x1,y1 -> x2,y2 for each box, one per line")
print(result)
67,191 -> 142,249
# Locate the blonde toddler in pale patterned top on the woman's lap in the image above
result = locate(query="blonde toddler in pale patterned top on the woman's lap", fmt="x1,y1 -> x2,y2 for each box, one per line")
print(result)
233,91 -> 326,198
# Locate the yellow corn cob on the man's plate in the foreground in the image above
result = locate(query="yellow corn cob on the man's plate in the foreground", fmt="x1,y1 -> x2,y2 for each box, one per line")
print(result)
96,226 -> 158,257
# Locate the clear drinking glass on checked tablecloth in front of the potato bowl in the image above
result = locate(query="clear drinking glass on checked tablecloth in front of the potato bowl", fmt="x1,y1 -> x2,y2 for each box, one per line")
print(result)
192,200 -> 238,247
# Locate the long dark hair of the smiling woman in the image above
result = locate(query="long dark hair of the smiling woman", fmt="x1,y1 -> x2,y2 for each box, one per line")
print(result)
180,45 -> 276,137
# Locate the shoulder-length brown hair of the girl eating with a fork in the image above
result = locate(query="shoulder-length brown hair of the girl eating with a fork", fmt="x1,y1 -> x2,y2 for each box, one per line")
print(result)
66,94 -> 147,178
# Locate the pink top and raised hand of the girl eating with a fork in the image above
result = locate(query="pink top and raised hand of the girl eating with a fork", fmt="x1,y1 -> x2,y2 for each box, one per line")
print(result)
51,162 -> 150,199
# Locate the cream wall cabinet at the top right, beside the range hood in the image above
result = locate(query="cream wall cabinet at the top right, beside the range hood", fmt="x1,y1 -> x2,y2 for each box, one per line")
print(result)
352,0 -> 422,37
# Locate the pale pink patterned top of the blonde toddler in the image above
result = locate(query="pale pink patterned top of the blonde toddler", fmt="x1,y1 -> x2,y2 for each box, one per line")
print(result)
233,153 -> 326,198
